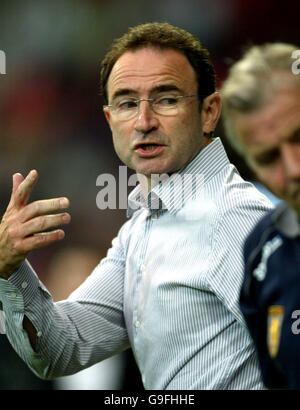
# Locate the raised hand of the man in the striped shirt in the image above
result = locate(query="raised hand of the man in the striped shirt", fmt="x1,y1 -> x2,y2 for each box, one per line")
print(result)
0,170 -> 71,279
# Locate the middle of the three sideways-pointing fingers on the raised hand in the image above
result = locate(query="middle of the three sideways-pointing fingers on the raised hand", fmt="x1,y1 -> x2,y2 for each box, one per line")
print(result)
19,213 -> 71,238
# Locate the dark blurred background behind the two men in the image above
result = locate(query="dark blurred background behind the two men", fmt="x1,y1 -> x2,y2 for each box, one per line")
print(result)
0,0 -> 300,390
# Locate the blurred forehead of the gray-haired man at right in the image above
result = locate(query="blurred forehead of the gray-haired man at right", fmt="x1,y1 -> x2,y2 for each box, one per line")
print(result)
234,87 -> 300,150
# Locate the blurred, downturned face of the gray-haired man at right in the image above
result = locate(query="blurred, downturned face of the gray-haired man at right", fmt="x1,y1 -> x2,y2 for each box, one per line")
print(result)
234,85 -> 300,215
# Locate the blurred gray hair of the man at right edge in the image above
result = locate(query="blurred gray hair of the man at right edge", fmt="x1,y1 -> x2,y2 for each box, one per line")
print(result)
220,43 -> 300,154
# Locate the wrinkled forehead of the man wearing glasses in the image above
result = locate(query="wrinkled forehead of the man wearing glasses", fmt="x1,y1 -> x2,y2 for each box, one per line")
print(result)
108,47 -> 197,96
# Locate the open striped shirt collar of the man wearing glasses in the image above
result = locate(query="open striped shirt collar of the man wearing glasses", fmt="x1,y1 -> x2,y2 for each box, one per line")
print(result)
127,138 -> 229,217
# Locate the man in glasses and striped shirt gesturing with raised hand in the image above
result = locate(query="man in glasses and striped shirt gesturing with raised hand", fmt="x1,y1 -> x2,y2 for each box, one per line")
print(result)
0,23 -> 271,389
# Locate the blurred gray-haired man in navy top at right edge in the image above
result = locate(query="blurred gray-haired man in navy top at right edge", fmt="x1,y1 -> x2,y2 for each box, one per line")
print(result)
222,43 -> 300,389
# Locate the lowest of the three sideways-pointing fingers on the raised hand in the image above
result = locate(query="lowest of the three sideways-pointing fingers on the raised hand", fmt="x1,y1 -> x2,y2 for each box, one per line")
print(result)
17,229 -> 65,255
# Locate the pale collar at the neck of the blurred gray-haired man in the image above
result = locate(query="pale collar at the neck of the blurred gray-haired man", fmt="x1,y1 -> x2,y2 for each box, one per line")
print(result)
272,202 -> 300,238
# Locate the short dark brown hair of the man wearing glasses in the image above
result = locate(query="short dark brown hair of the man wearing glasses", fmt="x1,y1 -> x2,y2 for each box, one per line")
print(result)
101,23 -> 216,104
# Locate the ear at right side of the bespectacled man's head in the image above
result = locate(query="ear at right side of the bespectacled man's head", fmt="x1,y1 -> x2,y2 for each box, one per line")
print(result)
201,92 -> 221,134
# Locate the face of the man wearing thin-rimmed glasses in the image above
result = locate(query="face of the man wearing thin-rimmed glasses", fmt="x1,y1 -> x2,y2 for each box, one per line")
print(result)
104,48 -> 218,183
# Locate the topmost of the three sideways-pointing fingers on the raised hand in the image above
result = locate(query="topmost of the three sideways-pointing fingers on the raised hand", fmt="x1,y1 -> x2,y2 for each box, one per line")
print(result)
20,197 -> 70,222
